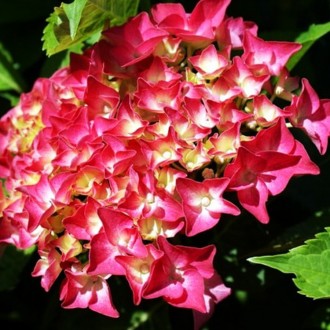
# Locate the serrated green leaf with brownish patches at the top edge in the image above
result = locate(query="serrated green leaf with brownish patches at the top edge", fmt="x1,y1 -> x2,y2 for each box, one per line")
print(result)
42,0 -> 139,56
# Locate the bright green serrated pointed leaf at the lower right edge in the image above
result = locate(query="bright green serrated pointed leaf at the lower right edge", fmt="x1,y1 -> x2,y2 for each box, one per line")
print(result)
248,227 -> 330,299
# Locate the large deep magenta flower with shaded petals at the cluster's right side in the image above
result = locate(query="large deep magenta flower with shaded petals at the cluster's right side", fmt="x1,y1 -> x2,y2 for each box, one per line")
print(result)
224,119 -> 319,223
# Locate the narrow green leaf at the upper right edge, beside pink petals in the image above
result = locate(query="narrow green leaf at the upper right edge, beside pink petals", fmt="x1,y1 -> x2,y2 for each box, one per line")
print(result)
287,22 -> 330,70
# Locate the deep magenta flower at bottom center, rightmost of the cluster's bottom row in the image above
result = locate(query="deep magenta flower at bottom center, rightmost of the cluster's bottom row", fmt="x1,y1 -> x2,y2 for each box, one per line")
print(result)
143,236 -> 228,314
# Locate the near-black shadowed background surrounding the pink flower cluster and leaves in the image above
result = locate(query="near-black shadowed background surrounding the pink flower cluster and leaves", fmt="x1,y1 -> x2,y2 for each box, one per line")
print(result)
0,0 -> 330,330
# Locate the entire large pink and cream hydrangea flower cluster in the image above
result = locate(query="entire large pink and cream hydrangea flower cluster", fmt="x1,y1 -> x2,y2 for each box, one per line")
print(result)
0,0 -> 330,328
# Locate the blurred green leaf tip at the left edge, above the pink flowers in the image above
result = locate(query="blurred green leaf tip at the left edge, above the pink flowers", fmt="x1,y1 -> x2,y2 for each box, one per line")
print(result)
0,43 -> 23,93
